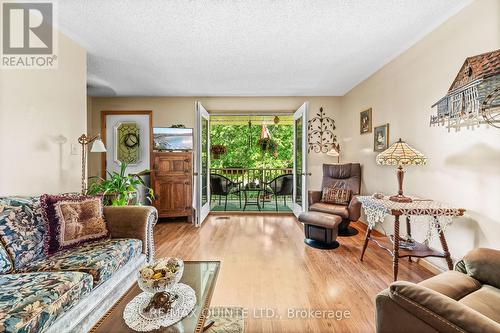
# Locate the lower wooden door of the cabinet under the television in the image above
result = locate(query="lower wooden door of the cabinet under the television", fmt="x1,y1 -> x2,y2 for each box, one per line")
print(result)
154,176 -> 192,217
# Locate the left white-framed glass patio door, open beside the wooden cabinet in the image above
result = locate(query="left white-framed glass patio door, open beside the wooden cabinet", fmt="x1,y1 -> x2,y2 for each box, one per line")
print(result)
193,102 -> 210,227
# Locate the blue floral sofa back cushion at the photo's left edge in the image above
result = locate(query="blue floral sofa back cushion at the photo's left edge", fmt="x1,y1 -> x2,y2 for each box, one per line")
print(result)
0,197 -> 46,270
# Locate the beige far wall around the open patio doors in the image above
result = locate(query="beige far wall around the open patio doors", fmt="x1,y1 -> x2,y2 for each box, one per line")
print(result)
89,97 -> 340,189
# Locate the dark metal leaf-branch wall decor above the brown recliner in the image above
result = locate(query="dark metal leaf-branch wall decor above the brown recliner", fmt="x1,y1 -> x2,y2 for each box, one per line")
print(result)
307,107 -> 338,153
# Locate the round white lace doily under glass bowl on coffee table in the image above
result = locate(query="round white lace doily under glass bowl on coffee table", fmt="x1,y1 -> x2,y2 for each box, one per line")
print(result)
123,283 -> 196,332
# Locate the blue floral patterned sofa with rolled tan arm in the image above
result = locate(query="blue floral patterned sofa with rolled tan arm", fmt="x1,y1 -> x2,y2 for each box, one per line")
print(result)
0,197 -> 157,333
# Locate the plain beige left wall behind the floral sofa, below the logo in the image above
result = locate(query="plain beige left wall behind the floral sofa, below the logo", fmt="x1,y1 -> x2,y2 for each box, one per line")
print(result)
0,34 -> 87,195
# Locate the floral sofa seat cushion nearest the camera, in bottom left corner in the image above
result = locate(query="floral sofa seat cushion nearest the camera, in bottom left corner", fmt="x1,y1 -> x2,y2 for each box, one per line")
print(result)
0,272 -> 92,333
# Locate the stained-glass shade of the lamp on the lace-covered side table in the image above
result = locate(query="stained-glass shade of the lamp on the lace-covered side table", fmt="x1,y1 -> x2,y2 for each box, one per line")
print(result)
377,139 -> 427,166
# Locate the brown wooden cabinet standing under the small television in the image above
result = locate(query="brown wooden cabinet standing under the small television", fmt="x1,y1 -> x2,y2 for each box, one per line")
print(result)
151,152 -> 193,220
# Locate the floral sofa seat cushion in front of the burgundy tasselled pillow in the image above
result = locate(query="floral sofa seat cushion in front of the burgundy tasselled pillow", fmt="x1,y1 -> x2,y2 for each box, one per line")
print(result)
26,238 -> 142,287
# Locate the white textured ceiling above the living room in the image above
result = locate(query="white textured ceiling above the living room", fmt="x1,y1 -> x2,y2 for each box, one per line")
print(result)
58,0 -> 470,96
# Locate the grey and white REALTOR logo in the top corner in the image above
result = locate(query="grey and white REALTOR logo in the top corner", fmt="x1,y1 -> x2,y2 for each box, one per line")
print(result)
1,2 -> 57,68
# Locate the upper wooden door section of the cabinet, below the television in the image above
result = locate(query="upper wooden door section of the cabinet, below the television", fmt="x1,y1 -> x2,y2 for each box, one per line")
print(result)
153,153 -> 192,177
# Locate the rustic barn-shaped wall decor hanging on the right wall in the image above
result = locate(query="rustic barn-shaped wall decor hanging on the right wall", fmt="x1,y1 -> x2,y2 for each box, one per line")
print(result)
430,50 -> 500,131
